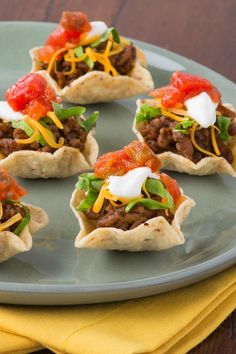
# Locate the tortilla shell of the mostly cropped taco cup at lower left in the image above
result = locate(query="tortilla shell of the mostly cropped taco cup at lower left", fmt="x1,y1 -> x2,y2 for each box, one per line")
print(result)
0,204 -> 48,262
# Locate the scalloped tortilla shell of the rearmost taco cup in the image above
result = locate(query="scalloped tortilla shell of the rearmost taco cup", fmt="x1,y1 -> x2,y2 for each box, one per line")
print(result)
30,47 -> 154,104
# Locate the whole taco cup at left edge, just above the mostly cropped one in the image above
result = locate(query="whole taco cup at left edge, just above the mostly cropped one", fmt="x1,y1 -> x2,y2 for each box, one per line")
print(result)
0,73 -> 98,178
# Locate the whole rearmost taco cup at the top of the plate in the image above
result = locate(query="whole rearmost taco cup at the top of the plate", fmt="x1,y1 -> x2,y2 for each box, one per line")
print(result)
30,11 -> 153,104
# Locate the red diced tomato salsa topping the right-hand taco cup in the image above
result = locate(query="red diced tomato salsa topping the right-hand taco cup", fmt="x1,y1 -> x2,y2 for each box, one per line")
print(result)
150,71 -> 221,108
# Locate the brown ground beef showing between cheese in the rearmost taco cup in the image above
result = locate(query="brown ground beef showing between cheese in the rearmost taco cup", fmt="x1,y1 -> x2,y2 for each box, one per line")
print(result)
42,42 -> 136,87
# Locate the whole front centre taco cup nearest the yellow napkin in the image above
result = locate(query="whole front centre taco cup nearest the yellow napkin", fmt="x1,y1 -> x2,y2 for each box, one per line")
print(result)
71,141 -> 195,251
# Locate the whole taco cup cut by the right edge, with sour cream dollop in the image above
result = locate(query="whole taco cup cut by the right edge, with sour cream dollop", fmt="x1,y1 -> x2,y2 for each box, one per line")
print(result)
133,72 -> 236,177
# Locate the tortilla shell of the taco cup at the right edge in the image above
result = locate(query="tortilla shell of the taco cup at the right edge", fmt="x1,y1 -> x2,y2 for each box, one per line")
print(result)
132,99 -> 236,177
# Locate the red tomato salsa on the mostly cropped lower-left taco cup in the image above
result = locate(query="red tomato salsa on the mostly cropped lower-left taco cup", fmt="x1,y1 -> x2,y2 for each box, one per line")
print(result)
0,169 -> 27,201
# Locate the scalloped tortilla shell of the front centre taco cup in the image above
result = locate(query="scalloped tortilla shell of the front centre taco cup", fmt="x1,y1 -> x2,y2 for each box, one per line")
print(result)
70,189 -> 195,252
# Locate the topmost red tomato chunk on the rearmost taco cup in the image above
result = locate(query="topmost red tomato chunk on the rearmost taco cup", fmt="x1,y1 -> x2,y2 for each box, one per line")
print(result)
60,11 -> 92,33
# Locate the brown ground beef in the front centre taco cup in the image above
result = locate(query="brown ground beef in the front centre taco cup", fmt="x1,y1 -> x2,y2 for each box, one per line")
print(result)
85,195 -> 174,231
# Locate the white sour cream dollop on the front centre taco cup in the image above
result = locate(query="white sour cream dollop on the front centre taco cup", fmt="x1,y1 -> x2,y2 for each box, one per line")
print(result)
107,167 -> 159,199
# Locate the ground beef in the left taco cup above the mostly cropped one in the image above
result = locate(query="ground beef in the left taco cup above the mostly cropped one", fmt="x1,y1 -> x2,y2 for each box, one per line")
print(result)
0,117 -> 88,157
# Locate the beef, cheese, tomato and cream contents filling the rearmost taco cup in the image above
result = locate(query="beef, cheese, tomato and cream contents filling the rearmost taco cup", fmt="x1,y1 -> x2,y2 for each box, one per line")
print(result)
37,12 -> 136,87
